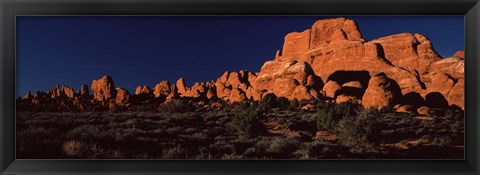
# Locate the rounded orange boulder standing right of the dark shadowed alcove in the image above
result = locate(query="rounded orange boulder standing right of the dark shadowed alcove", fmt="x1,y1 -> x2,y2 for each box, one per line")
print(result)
362,73 -> 402,109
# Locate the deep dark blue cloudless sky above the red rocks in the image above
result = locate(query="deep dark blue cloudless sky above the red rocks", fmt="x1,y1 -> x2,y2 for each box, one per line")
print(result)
16,16 -> 464,96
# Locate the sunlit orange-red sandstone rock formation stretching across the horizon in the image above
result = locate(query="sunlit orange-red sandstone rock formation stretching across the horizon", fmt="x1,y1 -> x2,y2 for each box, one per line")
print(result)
19,18 -> 464,111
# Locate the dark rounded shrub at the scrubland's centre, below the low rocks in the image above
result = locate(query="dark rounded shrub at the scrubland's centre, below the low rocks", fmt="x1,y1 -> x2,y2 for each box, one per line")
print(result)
227,107 -> 265,134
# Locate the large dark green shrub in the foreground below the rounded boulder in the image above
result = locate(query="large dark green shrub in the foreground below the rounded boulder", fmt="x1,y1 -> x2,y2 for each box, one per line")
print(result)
335,109 -> 380,149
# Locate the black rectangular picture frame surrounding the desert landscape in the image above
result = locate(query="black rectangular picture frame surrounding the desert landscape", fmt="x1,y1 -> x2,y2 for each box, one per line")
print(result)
0,0 -> 480,175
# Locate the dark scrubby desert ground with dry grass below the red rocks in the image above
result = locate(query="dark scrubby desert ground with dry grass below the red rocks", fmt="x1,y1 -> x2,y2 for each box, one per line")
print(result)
17,102 -> 464,159
